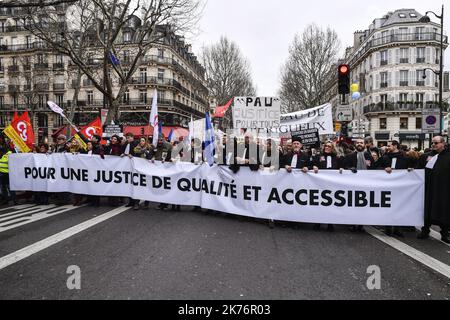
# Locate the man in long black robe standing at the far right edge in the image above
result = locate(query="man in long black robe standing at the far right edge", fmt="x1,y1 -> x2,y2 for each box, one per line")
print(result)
418,136 -> 450,243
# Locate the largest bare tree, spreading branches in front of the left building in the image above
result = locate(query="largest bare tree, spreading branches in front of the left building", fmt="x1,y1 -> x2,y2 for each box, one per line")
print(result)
24,0 -> 203,122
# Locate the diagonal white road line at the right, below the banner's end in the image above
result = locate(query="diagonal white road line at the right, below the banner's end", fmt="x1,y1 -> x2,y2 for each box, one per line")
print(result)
366,227 -> 450,278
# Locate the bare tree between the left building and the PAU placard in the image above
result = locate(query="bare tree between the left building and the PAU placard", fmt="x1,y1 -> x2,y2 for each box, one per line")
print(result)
202,37 -> 256,105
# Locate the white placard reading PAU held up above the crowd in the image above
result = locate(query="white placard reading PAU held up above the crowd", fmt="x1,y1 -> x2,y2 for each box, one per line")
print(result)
233,97 -> 281,129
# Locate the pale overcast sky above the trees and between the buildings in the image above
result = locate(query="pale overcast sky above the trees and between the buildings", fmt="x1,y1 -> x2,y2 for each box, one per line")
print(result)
193,0 -> 450,96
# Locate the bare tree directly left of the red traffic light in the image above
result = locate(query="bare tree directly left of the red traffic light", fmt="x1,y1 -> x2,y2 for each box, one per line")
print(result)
280,24 -> 340,113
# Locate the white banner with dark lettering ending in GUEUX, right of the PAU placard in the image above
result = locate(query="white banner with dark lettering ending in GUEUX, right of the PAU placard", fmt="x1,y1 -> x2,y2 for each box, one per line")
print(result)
272,103 -> 334,135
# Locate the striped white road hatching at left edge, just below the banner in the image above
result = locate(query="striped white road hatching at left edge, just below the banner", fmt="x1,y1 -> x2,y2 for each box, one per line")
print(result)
0,205 -> 86,233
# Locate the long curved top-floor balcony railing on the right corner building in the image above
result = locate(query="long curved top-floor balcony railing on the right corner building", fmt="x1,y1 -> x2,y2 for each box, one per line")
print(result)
349,32 -> 448,66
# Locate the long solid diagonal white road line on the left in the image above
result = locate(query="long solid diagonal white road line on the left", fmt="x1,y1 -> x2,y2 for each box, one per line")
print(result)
0,206 -> 129,270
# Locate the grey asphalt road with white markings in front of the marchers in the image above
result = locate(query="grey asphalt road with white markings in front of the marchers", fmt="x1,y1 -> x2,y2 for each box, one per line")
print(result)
0,200 -> 450,300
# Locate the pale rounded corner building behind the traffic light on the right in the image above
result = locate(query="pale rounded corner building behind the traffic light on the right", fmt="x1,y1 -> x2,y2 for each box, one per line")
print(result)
345,9 -> 448,149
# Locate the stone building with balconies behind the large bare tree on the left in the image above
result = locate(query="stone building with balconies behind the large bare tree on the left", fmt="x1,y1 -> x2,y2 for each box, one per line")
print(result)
0,9 -> 209,141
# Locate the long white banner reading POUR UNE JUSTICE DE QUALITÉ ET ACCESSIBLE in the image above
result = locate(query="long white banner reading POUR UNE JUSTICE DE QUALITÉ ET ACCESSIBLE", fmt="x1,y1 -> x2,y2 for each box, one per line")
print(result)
10,154 -> 424,226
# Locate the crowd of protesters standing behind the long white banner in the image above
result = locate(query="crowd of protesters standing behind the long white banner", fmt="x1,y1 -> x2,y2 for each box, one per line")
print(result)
0,133 -> 450,243
